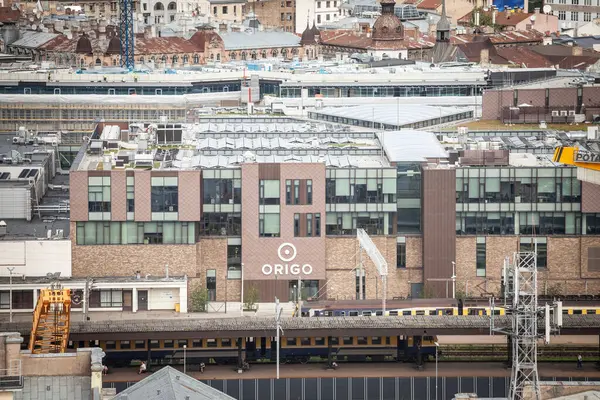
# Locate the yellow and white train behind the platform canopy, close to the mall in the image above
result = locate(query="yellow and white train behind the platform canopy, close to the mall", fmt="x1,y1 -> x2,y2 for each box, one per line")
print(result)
301,296 -> 600,317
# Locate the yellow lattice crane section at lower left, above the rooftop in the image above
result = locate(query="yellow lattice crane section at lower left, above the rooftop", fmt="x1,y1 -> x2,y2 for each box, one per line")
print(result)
29,284 -> 71,354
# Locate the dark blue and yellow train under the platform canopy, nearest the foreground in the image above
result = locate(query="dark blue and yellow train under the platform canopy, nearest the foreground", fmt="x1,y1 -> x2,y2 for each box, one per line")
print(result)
67,336 -> 438,367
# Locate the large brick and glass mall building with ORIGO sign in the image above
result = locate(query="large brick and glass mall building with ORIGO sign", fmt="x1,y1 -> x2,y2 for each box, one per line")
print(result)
70,118 -> 600,302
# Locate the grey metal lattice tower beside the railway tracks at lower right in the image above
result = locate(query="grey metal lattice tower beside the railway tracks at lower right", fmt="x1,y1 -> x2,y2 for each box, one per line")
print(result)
505,252 -> 542,400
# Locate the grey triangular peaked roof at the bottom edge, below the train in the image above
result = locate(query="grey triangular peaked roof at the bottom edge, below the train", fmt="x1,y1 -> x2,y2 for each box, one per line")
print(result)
113,366 -> 234,400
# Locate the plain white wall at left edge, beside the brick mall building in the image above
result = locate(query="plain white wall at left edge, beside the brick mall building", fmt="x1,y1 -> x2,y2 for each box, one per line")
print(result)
0,240 -> 71,278
